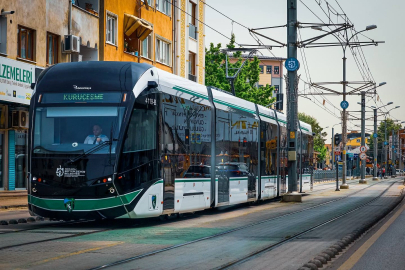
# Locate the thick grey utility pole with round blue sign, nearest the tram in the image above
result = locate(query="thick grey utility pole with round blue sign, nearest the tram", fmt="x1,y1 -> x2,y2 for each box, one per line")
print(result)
283,0 -> 302,202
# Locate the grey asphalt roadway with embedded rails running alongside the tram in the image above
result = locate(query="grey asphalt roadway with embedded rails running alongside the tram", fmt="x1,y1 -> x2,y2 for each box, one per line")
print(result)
0,179 -> 400,269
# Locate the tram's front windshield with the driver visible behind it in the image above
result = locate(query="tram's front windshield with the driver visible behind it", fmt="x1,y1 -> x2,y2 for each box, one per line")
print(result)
33,106 -> 125,154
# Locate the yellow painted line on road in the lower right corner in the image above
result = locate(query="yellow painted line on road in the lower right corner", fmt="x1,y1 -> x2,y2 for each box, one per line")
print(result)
338,201 -> 405,270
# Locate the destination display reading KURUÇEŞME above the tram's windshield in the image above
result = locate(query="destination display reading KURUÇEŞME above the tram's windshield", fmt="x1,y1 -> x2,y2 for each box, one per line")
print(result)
41,92 -> 122,104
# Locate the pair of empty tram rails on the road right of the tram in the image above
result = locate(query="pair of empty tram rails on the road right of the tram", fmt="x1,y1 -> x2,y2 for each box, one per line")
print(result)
90,178 -> 396,270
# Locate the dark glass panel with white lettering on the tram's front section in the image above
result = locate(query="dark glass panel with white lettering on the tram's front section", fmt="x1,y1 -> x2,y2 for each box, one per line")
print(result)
162,95 -> 211,179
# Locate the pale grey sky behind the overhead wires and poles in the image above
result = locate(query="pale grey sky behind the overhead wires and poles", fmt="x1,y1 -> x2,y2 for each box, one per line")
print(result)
205,0 -> 405,143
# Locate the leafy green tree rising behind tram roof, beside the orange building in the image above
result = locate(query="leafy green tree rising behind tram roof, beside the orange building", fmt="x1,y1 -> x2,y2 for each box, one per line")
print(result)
205,35 -> 275,106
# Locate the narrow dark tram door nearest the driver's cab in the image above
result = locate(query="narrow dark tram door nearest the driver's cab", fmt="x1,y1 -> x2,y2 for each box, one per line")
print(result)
162,106 -> 178,210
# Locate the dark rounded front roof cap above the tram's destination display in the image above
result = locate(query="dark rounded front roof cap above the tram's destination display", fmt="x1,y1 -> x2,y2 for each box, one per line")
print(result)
36,61 -> 152,92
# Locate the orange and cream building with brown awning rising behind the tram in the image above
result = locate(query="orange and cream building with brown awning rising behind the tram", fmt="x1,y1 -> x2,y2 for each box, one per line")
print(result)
99,0 -> 205,84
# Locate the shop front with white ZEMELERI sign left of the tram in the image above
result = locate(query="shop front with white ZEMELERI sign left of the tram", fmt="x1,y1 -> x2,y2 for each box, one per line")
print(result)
0,57 -> 42,190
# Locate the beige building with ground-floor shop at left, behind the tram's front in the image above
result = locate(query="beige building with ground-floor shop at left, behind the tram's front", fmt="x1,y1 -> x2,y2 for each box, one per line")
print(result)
0,0 -> 99,190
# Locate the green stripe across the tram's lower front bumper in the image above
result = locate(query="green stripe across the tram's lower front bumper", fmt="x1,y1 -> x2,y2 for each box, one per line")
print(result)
29,189 -> 141,211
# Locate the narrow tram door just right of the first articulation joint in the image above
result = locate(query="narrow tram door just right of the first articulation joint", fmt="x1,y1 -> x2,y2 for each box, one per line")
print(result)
217,119 -> 231,203
